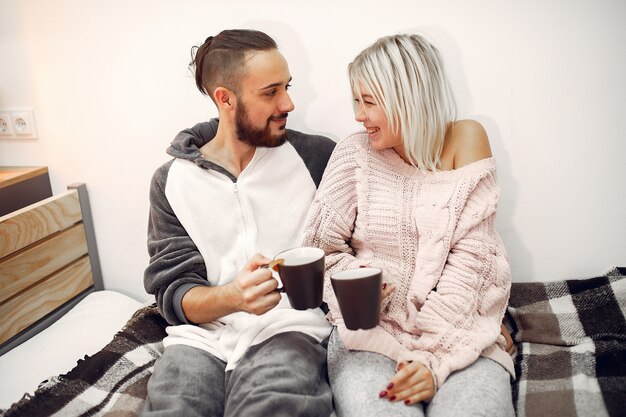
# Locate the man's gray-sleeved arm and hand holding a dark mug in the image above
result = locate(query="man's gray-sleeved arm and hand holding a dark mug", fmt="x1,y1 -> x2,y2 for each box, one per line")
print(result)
144,163 -> 280,325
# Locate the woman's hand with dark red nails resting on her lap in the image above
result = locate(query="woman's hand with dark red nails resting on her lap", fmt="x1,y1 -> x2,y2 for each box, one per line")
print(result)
379,361 -> 435,405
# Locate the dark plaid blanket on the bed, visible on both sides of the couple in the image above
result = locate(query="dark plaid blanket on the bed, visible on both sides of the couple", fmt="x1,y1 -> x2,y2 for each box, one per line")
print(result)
0,268 -> 626,417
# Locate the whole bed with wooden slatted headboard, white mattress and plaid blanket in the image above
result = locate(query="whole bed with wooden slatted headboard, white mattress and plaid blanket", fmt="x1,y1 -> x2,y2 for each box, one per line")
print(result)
0,184 -> 626,417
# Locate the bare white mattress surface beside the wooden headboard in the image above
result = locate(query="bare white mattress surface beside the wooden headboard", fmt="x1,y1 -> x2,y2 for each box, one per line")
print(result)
0,291 -> 142,410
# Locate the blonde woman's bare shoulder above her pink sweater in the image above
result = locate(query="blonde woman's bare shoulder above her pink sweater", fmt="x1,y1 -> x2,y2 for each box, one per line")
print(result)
446,120 -> 492,169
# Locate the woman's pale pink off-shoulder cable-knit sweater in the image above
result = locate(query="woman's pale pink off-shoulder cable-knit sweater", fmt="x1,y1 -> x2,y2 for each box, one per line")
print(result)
304,132 -> 515,386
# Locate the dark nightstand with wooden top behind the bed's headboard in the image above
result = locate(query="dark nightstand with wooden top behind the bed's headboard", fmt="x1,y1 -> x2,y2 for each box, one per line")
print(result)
0,166 -> 52,216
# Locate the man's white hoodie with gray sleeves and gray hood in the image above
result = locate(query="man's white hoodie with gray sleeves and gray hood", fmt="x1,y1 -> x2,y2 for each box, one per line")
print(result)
144,119 -> 335,370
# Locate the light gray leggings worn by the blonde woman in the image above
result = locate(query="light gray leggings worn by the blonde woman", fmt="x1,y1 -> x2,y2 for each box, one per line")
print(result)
328,329 -> 515,417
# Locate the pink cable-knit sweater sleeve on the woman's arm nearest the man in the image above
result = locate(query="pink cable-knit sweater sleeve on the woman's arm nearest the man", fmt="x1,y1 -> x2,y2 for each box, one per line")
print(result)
302,137 -> 365,314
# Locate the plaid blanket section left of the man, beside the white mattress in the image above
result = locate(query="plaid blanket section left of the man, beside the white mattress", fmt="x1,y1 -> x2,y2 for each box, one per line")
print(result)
0,306 -> 167,417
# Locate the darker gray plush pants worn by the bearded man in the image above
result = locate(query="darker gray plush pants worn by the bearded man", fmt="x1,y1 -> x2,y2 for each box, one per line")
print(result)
142,332 -> 332,417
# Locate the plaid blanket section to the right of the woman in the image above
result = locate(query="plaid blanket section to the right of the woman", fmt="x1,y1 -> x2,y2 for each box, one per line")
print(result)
505,268 -> 626,417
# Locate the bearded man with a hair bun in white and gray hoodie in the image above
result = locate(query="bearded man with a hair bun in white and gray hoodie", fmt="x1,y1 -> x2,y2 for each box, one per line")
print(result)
144,30 -> 334,416
